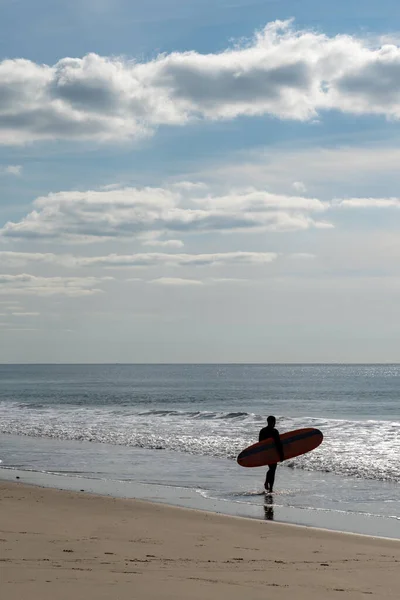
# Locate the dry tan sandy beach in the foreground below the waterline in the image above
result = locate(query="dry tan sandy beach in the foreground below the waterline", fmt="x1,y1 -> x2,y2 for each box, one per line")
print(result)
0,483 -> 400,600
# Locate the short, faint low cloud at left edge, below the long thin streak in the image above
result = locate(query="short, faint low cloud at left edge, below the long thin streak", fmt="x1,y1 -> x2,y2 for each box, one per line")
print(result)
0,273 -> 110,297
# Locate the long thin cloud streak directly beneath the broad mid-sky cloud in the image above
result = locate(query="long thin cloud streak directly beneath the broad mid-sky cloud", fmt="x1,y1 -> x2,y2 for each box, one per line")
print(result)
0,251 -> 278,268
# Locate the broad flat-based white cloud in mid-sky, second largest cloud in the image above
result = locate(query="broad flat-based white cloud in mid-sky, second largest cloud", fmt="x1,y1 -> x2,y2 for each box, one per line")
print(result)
0,187 -> 331,242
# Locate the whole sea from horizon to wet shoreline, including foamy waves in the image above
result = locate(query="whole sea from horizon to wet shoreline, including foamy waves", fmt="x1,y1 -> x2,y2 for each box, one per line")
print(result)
0,365 -> 400,538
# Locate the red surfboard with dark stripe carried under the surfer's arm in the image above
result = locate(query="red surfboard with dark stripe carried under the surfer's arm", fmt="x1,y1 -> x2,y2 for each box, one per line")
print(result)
237,427 -> 324,467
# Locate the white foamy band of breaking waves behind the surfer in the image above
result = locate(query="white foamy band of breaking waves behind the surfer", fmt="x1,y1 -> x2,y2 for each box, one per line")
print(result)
0,402 -> 400,482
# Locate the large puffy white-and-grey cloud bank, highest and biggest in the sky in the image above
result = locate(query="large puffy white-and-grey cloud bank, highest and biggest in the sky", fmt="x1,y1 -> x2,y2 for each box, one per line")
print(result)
5,21 -> 400,144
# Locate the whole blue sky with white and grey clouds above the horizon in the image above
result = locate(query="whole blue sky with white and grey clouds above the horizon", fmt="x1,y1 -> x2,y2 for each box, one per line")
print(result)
0,0 -> 400,363
